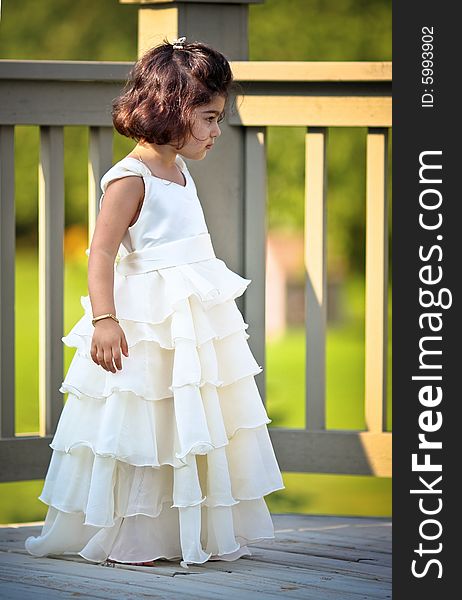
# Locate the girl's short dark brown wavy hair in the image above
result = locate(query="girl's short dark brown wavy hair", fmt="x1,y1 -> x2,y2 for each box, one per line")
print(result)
112,38 -> 235,149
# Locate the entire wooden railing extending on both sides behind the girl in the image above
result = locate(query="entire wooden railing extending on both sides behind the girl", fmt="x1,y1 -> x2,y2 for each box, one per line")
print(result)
0,60 -> 391,481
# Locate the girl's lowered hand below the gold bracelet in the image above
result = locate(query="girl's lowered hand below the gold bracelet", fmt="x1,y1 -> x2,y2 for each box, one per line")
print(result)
90,319 -> 128,373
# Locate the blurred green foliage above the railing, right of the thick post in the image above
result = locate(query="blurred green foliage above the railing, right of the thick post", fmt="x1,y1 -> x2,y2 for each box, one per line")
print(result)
249,0 -> 391,61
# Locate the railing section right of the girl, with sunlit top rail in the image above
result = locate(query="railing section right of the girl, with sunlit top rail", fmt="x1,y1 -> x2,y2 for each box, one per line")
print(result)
230,61 -> 391,476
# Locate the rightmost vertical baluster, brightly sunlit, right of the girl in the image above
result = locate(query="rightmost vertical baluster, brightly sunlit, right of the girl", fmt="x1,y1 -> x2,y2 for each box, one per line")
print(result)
365,127 -> 388,432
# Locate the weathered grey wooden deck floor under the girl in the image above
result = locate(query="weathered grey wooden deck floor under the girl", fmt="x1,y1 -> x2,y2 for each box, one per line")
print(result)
0,514 -> 391,600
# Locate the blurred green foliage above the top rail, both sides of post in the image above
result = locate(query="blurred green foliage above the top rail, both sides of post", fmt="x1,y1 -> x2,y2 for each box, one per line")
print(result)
0,0 -> 391,61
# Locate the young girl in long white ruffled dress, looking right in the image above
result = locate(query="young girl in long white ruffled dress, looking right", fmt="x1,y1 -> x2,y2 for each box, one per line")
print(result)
25,38 -> 285,567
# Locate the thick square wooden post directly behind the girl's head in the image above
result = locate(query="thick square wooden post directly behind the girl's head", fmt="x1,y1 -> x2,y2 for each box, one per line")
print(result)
119,0 -> 265,392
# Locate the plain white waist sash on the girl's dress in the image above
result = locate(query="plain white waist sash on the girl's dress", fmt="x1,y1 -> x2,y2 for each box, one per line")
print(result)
115,233 -> 216,275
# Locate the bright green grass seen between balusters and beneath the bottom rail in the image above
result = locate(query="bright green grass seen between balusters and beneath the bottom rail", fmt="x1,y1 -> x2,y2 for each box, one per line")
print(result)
0,250 -> 391,523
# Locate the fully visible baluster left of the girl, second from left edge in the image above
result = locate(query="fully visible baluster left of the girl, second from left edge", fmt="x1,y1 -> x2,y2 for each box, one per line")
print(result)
39,126 -> 64,435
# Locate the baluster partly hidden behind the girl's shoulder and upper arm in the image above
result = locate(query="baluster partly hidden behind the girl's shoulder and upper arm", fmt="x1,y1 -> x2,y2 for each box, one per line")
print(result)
88,127 -> 113,243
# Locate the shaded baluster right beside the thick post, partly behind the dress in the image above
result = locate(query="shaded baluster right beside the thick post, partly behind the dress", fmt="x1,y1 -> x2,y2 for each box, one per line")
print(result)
244,127 -> 266,401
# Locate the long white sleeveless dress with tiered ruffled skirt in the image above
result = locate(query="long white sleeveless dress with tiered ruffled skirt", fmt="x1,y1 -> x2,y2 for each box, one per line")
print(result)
25,155 -> 285,568
